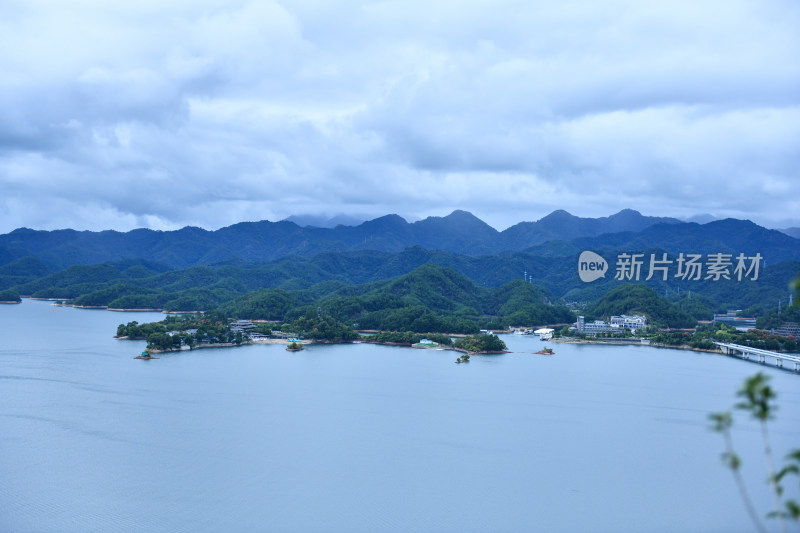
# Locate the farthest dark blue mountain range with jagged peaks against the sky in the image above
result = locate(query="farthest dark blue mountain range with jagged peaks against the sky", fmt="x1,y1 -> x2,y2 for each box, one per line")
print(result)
0,209 -> 800,272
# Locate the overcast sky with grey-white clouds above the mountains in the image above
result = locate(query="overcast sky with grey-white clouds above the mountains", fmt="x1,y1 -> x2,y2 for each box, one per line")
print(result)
0,0 -> 800,233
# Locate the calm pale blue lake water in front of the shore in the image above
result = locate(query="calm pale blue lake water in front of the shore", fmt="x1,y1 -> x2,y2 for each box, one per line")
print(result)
0,300 -> 800,532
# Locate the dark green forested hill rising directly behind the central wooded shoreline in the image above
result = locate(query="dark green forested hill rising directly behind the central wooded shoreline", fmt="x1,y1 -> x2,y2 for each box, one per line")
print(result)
219,264 -> 574,333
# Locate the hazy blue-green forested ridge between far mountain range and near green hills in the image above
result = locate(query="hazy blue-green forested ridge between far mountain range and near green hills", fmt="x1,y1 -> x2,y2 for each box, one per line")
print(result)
0,241 -> 800,316
